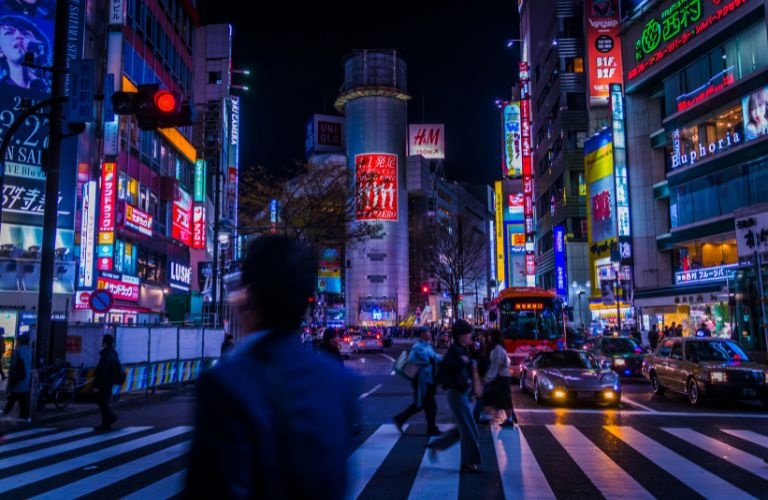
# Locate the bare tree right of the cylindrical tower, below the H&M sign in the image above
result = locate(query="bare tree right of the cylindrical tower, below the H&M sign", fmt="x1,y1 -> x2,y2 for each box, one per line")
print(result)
424,216 -> 486,319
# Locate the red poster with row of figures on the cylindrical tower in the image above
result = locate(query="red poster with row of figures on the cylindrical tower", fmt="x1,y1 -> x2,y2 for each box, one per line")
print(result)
355,153 -> 398,221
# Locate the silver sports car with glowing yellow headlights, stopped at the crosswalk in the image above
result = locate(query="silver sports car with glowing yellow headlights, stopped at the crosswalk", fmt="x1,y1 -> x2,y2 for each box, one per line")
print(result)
520,350 -> 621,407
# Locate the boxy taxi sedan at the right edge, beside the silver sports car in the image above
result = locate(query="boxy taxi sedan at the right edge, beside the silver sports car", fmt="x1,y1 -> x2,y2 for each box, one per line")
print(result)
643,337 -> 768,408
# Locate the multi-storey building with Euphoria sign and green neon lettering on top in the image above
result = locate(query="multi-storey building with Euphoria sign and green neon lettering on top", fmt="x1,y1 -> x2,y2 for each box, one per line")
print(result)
621,0 -> 768,350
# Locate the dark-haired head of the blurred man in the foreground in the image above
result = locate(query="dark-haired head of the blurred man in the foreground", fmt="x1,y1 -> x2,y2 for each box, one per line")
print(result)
241,236 -> 316,331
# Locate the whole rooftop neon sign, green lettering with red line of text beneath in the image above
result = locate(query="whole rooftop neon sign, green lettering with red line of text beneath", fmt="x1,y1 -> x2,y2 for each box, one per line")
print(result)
627,0 -> 747,80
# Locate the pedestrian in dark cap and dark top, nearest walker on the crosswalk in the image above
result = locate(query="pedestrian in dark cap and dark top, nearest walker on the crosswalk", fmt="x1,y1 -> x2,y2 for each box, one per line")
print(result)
427,319 -> 481,472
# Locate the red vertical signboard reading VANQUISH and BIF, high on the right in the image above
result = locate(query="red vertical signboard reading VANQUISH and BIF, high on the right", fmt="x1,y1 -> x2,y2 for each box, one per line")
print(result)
584,0 -> 623,107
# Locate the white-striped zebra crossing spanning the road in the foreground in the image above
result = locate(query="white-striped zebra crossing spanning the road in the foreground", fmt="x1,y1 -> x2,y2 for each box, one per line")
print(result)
0,424 -> 768,500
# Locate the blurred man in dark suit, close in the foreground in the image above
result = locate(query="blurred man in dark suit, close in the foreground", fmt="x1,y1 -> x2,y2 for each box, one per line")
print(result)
184,235 -> 357,500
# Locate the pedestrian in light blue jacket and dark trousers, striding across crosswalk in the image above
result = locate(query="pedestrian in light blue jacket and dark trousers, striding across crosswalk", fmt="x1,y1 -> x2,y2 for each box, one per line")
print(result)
395,328 -> 441,436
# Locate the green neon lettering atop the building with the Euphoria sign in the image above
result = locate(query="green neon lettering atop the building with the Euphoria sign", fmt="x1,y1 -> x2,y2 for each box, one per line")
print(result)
635,0 -> 701,62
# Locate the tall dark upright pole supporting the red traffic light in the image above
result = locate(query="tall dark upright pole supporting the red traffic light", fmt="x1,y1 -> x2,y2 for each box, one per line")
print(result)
34,1 -> 69,367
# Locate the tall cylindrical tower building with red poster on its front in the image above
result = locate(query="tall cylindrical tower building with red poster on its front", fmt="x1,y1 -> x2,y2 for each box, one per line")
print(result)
336,50 -> 410,326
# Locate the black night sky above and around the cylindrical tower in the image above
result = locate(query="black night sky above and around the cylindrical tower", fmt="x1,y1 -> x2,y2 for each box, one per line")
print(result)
198,0 -> 519,183
